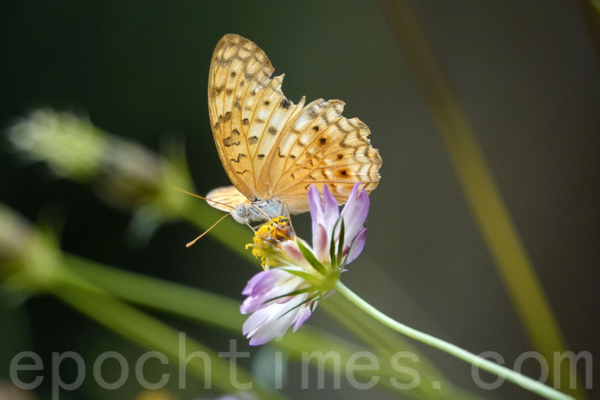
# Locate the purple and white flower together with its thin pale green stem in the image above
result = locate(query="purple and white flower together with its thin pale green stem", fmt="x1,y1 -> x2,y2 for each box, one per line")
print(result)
241,184 -> 572,400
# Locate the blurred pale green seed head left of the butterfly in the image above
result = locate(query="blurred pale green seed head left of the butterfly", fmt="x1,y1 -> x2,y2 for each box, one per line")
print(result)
8,109 -> 193,231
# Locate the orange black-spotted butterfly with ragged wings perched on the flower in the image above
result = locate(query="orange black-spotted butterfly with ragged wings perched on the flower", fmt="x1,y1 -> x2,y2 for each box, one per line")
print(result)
206,34 -> 381,224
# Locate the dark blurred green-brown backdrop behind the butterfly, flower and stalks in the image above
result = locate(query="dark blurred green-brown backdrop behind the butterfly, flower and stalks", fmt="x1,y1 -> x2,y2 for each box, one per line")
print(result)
0,0 -> 600,399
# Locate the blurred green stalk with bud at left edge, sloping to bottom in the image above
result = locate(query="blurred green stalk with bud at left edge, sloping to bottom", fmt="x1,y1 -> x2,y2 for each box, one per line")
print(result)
0,209 -> 286,400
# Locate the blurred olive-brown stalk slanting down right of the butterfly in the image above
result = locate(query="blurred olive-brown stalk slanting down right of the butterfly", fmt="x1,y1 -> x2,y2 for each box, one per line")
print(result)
379,0 -> 586,399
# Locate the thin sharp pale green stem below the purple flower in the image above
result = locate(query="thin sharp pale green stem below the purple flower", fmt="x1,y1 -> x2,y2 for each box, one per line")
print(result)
336,282 -> 573,399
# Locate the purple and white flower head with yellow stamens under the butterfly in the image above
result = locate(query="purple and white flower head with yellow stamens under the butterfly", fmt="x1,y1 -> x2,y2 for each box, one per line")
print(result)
240,184 -> 369,346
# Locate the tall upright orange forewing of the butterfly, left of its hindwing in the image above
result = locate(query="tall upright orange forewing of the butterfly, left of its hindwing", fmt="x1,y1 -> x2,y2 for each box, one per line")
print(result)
208,35 -> 302,200
